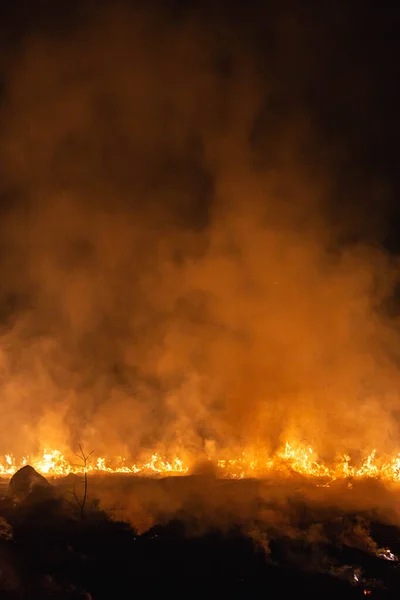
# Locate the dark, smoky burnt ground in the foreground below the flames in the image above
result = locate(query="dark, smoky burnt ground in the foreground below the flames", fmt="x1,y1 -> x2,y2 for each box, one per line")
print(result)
0,477 -> 400,599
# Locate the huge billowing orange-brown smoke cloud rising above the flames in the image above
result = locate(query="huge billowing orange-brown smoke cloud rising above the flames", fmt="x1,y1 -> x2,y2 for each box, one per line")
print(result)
0,3 -> 400,462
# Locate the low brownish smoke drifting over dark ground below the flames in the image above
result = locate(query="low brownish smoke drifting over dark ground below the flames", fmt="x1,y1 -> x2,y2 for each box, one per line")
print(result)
85,476 -> 399,564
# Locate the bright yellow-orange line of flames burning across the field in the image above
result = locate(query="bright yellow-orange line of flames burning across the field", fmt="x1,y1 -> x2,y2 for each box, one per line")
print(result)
0,442 -> 400,485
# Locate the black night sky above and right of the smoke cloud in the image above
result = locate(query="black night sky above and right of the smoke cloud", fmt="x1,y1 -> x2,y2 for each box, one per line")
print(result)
0,0 -> 400,244
